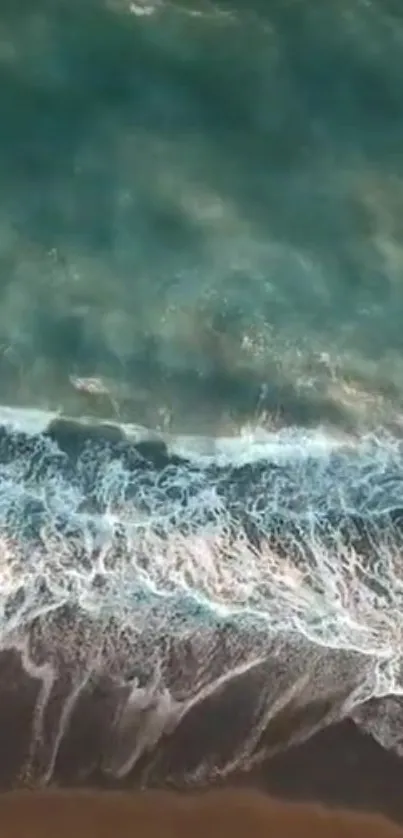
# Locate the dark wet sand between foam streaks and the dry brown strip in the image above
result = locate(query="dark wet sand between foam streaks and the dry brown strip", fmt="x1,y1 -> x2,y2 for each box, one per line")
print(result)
0,640 -> 403,834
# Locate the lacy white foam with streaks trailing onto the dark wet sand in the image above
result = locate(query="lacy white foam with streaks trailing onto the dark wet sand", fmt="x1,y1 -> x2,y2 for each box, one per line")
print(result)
0,408 -> 403,776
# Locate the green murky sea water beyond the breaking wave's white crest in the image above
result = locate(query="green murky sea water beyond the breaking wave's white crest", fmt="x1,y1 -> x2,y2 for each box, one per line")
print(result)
0,0 -> 403,433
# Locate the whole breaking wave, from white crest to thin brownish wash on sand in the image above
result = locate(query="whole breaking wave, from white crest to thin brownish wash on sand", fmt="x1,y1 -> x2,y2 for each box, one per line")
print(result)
0,408 -> 403,784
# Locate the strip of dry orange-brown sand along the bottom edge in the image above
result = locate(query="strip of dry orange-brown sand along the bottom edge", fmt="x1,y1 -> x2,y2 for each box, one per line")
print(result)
0,790 -> 403,838
